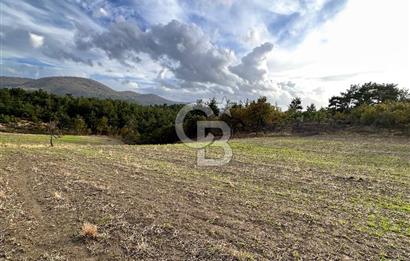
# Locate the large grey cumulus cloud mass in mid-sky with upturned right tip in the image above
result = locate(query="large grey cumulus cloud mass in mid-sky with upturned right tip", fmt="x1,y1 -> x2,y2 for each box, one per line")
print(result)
70,20 -> 284,100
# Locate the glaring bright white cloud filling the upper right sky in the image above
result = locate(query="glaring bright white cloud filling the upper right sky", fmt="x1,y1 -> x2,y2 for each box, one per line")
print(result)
268,0 -> 410,105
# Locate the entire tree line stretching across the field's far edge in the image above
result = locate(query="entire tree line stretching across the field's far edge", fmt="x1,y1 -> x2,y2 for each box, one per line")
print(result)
0,83 -> 410,144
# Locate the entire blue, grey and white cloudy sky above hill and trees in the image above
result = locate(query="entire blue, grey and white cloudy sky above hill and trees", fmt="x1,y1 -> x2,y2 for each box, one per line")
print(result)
0,0 -> 410,106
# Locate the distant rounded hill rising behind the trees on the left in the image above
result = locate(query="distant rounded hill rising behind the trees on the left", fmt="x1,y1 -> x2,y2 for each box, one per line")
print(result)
0,76 -> 177,105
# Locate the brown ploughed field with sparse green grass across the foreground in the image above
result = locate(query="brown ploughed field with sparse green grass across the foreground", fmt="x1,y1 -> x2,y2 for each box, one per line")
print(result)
0,134 -> 410,260
